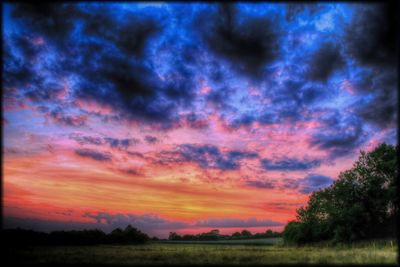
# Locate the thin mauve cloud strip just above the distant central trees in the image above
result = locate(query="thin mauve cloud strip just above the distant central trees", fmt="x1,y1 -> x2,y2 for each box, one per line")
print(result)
195,218 -> 284,228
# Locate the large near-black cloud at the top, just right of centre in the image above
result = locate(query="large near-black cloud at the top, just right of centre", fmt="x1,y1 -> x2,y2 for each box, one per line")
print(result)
197,4 -> 279,77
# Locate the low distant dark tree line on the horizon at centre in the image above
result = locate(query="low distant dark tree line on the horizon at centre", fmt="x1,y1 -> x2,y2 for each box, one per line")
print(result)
168,229 -> 282,241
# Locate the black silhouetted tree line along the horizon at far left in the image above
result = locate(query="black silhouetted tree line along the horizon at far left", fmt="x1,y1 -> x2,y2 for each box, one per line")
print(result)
2,225 -> 150,246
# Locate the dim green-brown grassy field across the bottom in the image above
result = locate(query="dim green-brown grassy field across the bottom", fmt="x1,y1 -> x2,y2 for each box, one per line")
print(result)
6,242 -> 397,265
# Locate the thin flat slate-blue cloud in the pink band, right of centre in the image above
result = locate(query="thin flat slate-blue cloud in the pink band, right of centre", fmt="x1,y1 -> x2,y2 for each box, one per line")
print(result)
260,158 -> 322,171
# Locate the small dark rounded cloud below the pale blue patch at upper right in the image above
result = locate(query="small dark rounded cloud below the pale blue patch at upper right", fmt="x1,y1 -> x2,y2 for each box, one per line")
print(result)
308,43 -> 344,82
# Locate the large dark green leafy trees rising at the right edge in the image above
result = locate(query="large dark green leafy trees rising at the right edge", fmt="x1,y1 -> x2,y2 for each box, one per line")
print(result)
283,143 -> 399,244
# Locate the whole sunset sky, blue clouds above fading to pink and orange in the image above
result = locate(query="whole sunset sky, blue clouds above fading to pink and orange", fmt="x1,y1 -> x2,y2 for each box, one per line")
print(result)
2,2 -> 397,240
